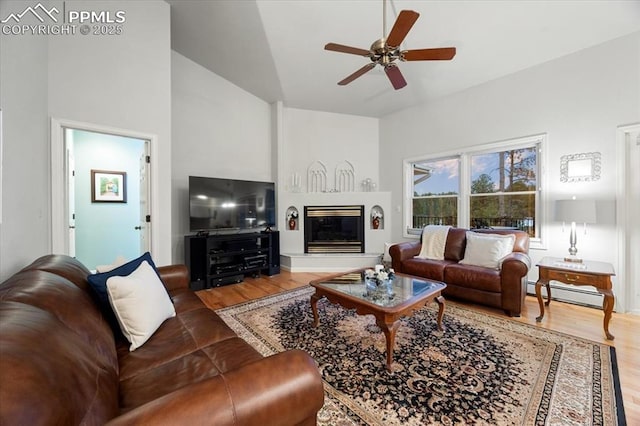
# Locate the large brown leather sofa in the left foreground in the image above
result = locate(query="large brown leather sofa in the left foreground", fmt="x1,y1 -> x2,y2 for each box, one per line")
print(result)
0,255 -> 324,426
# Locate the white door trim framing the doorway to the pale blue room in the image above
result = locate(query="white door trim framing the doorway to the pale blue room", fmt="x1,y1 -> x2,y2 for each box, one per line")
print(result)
51,117 -> 160,262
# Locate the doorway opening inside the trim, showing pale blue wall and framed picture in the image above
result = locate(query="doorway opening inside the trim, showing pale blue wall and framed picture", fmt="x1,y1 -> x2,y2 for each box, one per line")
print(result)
64,128 -> 149,269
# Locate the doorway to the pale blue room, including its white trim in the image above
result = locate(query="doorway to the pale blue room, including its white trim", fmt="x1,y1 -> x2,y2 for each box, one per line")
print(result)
51,119 -> 158,269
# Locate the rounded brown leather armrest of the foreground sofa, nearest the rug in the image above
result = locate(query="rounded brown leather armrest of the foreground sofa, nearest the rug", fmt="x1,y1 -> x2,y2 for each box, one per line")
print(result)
107,350 -> 324,426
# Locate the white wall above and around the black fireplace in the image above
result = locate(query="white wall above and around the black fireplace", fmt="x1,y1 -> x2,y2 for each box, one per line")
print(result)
277,107 -> 382,253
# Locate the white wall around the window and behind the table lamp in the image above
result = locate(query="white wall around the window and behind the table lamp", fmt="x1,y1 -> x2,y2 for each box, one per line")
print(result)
380,33 -> 640,310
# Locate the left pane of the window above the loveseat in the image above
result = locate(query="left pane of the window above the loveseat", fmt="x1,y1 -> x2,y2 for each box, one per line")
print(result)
412,157 -> 460,228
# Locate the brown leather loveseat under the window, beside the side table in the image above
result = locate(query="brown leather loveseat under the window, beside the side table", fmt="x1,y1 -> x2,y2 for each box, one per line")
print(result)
389,228 -> 531,316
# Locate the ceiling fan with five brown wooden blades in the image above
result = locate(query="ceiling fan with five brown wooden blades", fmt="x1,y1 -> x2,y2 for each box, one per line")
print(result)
324,0 -> 456,90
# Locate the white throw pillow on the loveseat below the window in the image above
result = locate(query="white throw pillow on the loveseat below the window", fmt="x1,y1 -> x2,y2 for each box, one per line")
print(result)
460,231 -> 516,269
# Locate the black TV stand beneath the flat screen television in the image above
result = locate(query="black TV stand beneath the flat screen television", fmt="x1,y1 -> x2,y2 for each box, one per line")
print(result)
184,231 -> 280,290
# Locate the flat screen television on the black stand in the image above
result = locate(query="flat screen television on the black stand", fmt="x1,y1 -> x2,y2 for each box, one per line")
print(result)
189,176 -> 276,232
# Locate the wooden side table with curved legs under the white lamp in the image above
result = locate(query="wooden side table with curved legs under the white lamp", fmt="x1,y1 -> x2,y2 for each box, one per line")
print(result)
536,257 -> 616,340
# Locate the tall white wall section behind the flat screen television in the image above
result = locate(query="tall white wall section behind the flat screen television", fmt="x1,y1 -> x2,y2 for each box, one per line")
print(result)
171,52 -> 278,262
